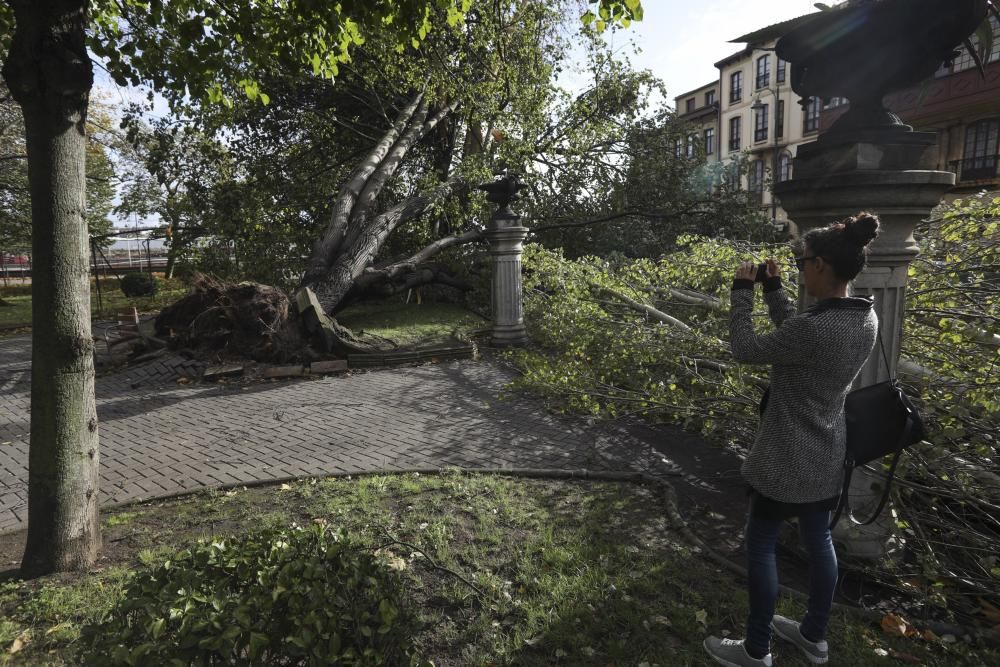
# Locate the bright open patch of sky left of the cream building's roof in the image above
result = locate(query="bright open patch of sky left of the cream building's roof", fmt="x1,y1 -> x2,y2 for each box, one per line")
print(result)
615,0 -> 833,106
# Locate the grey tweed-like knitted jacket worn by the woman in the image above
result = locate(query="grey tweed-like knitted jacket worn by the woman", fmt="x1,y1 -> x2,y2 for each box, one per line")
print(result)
729,279 -> 878,503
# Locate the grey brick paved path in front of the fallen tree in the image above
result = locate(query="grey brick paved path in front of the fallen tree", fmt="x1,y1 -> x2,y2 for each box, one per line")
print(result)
0,337 -> 688,531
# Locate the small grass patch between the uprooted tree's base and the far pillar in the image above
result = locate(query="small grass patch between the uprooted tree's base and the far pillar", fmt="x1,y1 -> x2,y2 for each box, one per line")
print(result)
337,297 -> 487,347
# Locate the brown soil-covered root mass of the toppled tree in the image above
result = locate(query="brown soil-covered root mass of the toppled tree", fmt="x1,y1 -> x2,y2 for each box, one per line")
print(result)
156,275 -> 390,362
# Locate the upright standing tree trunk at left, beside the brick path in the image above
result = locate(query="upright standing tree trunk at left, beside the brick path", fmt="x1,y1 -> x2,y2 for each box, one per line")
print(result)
4,0 -> 100,576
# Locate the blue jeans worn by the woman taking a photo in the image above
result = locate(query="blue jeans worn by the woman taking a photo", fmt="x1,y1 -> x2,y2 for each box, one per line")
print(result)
746,511 -> 838,652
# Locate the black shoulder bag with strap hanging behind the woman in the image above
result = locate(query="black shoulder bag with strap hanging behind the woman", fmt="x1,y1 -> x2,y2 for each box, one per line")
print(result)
830,331 -> 927,528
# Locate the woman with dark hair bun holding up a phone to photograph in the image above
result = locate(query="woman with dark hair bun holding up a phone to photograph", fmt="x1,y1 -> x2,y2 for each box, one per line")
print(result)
704,213 -> 879,666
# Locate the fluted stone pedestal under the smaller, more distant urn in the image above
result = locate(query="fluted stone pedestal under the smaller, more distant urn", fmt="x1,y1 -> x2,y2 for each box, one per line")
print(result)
486,220 -> 528,346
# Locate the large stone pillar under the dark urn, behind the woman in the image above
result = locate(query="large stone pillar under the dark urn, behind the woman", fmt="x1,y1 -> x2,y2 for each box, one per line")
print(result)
775,130 -> 955,558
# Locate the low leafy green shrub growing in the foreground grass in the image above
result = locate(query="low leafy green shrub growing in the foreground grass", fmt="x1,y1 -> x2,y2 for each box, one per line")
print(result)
82,525 -> 429,666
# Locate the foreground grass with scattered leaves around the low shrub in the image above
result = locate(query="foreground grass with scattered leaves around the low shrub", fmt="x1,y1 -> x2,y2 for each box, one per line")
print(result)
0,472 -> 1000,667
